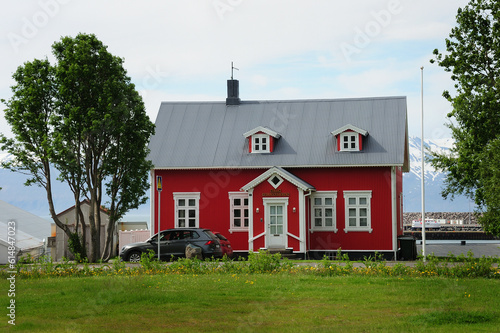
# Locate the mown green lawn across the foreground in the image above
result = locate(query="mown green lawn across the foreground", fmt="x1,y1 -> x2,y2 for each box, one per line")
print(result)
0,273 -> 500,332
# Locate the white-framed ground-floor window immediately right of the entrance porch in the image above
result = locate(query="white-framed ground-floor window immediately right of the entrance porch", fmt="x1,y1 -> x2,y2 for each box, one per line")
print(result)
311,191 -> 338,233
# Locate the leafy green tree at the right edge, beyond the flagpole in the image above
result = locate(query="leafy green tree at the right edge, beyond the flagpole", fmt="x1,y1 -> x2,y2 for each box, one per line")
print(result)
431,0 -> 500,235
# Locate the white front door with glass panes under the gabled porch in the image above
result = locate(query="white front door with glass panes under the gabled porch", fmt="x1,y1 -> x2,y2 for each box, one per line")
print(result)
265,201 -> 287,249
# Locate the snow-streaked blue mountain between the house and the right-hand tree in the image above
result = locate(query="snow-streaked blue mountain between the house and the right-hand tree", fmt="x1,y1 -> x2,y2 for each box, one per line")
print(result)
403,137 -> 474,212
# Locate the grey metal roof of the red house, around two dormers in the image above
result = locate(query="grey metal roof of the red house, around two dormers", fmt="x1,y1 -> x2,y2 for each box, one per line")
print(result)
149,97 -> 409,170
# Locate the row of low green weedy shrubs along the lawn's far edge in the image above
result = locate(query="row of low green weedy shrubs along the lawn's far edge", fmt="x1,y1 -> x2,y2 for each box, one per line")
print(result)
0,251 -> 500,279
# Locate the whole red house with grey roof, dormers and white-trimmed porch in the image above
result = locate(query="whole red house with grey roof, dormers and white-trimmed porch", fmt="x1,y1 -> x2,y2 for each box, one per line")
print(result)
149,80 -> 409,258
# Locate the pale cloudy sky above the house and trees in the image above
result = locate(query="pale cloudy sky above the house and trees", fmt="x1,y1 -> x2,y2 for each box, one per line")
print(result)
0,0 -> 467,139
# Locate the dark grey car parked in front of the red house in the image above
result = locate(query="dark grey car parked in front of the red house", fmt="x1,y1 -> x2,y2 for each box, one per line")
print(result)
120,228 -> 223,262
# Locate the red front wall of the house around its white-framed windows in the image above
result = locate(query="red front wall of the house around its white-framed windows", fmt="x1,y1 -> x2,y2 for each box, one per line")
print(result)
151,167 -> 402,251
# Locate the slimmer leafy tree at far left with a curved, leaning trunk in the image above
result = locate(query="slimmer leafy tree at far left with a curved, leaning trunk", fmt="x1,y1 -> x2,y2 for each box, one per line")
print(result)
0,59 -> 82,249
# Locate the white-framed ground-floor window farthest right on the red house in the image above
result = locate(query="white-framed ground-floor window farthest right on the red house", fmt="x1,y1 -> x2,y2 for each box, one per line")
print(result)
344,191 -> 373,233
